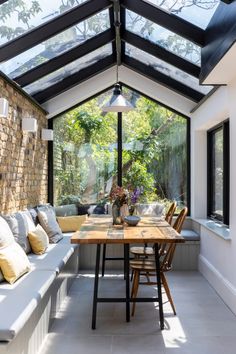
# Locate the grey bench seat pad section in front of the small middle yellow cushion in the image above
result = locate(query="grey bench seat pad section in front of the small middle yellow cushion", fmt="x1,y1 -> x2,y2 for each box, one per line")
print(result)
28,244 -> 74,274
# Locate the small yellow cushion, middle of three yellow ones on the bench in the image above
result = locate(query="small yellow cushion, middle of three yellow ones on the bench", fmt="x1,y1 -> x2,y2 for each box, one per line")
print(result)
28,224 -> 49,254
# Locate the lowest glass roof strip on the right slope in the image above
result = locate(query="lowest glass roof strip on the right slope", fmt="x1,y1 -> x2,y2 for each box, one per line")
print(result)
125,43 -> 212,95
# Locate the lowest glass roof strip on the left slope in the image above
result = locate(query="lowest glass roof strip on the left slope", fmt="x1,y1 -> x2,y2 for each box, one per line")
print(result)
24,43 -> 112,95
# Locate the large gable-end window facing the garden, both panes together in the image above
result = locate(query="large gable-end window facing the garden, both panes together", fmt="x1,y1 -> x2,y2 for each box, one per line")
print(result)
53,87 -> 189,207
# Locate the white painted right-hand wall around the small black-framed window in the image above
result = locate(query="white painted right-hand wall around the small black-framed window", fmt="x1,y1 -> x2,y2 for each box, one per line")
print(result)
191,80 -> 236,313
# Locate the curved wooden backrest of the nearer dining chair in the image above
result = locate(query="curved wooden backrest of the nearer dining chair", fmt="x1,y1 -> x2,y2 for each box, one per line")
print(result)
160,207 -> 188,272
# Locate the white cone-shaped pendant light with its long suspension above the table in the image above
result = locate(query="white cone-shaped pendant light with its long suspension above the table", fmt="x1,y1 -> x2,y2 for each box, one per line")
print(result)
102,0 -> 134,112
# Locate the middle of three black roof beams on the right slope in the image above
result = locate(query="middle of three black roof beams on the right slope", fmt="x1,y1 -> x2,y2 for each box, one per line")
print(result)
122,31 -> 200,78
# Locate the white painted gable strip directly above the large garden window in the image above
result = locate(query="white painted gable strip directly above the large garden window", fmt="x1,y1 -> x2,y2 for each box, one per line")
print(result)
43,66 -> 196,118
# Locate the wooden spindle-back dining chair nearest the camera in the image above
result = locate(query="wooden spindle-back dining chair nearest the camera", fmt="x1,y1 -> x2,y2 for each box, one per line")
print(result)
130,207 -> 188,316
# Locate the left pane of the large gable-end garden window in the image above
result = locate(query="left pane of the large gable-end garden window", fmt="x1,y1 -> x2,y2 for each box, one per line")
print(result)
53,92 -> 117,205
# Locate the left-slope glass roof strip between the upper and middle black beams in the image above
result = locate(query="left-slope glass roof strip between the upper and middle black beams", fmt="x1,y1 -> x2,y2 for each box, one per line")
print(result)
0,10 -> 110,78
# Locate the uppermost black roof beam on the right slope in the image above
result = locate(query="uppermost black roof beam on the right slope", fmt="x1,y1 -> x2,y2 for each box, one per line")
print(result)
122,0 -> 205,47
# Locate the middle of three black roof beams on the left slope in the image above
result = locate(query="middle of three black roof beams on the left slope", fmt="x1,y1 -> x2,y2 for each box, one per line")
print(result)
13,29 -> 115,86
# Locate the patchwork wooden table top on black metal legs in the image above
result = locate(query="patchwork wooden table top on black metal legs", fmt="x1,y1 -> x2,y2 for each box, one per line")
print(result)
71,215 -> 184,244
